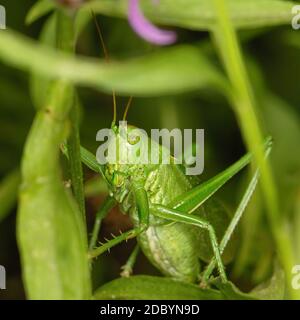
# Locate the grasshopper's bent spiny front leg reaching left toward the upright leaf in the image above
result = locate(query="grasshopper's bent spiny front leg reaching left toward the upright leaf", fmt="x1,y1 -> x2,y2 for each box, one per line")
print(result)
89,184 -> 149,258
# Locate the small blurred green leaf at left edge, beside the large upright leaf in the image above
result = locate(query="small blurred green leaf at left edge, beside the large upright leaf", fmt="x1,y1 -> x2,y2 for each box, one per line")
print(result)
0,170 -> 21,222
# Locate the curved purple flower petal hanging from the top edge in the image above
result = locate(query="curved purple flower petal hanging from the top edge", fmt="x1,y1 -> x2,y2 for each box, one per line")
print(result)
128,0 -> 177,45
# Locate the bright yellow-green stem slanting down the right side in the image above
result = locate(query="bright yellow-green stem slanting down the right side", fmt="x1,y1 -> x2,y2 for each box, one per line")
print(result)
213,0 -> 299,299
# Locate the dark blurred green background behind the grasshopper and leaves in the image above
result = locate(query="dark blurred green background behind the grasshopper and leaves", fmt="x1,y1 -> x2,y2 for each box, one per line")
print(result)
0,0 -> 300,299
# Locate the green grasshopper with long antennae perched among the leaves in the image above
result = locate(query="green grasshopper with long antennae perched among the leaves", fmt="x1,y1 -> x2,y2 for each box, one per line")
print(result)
72,14 -> 271,284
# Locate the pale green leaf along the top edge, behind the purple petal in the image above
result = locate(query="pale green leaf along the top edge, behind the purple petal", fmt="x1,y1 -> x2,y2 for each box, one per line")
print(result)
82,0 -> 295,30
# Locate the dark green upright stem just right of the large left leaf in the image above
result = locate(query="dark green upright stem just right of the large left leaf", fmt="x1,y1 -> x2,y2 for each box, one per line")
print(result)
56,10 -> 85,221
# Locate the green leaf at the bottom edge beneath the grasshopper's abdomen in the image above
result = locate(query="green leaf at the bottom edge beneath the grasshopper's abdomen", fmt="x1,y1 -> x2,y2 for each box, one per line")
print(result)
94,276 -> 222,300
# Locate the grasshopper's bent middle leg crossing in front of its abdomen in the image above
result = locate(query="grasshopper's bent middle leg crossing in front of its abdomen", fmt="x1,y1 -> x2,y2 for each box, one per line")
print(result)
151,205 -> 227,282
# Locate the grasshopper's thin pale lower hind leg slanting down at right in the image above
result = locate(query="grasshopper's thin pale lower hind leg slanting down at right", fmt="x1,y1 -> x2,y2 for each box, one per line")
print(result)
202,170 -> 259,283
